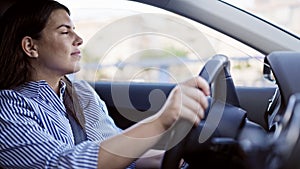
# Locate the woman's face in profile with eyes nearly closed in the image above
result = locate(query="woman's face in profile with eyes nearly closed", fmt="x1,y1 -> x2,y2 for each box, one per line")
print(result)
33,9 -> 82,76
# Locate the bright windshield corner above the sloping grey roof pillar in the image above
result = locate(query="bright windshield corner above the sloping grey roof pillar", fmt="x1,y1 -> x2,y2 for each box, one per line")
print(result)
222,0 -> 300,37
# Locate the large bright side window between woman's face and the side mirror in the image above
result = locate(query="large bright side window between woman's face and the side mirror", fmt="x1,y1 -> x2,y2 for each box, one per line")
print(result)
62,1 -> 271,86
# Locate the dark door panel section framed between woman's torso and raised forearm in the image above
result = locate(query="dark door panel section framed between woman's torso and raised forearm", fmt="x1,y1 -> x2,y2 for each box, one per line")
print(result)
93,82 -> 175,128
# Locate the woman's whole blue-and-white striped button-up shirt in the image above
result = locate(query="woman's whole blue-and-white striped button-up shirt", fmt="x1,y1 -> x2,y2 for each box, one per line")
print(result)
0,81 -> 127,169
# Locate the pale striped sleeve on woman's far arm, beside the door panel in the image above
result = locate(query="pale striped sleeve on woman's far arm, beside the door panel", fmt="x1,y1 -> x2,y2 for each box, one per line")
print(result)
73,81 -> 122,142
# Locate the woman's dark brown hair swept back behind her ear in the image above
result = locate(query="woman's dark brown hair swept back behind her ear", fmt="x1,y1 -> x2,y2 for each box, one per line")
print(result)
0,0 -> 70,90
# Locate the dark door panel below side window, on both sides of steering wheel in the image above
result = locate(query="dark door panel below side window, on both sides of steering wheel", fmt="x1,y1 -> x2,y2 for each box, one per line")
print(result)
92,82 -> 275,129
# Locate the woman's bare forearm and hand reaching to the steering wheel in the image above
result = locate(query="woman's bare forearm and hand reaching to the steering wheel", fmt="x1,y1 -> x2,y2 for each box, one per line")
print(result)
98,77 -> 209,169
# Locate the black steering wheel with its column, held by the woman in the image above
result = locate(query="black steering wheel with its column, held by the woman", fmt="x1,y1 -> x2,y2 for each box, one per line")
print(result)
161,55 -> 246,169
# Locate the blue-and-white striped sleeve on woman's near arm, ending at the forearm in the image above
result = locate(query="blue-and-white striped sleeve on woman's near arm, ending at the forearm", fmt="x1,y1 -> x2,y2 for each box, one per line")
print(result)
0,91 -> 100,169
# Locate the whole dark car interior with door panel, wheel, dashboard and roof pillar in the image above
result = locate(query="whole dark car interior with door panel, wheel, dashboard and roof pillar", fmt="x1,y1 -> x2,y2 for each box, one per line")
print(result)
0,0 -> 300,169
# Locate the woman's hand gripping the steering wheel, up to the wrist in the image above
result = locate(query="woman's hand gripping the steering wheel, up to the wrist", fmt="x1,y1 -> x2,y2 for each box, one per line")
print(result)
157,77 -> 210,130
